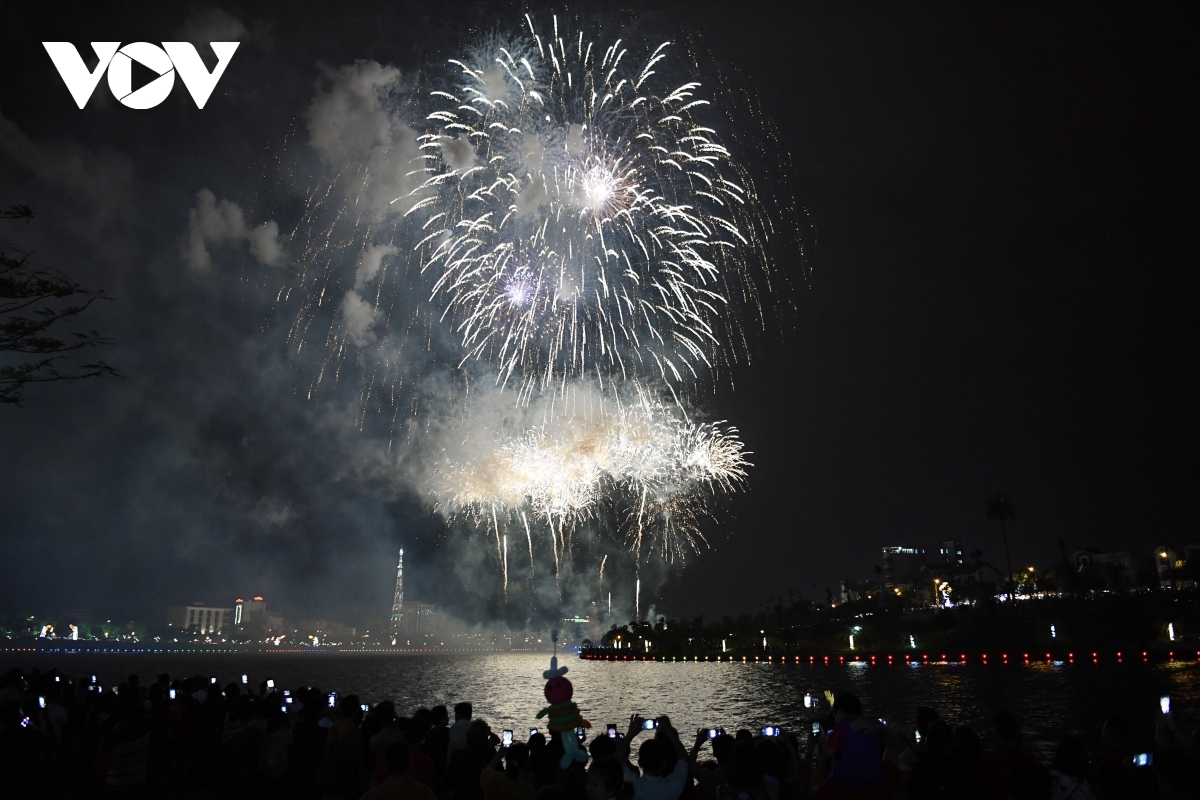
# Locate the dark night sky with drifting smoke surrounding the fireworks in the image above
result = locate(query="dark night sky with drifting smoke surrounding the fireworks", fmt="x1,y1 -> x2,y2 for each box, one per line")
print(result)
0,2 -> 1200,622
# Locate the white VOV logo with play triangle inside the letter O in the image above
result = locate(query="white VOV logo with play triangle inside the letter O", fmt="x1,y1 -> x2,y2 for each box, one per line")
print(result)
42,42 -> 240,108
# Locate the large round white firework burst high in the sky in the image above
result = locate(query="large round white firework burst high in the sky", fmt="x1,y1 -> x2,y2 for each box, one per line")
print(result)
406,16 -> 763,397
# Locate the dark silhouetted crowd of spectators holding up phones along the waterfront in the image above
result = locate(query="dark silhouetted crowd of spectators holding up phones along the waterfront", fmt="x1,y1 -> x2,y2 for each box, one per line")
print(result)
0,670 -> 1200,800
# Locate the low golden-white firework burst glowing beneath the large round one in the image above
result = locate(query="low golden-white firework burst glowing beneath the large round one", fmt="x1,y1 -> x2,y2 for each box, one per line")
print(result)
437,383 -> 749,566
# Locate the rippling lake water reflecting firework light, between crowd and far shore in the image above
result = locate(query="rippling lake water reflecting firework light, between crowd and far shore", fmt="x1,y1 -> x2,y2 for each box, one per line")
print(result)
11,654 -> 1200,758
